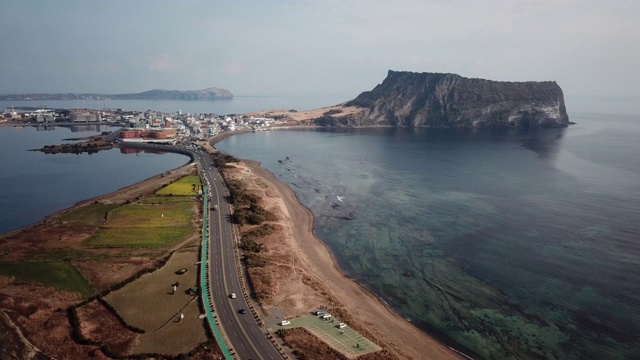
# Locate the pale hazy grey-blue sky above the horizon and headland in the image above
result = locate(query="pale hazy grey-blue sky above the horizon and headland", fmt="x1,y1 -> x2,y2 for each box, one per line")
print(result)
0,0 -> 640,97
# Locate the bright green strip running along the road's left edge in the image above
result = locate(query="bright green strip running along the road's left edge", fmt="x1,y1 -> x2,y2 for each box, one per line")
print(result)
200,184 -> 233,360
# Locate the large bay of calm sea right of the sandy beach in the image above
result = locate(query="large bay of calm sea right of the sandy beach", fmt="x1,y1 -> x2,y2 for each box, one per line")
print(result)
216,99 -> 640,359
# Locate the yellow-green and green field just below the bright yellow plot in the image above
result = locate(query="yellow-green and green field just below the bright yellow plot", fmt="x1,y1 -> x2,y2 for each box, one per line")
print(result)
85,202 -> 194,248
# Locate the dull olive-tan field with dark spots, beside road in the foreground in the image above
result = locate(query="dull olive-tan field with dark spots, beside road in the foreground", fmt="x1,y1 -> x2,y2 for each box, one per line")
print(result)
105,249 -> 207,355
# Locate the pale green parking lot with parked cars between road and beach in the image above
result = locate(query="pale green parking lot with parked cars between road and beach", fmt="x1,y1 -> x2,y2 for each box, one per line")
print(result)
276,315 -> 381,358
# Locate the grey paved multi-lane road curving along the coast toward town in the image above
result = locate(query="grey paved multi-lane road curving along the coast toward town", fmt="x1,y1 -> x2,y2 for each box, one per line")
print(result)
198,153 -> 282,360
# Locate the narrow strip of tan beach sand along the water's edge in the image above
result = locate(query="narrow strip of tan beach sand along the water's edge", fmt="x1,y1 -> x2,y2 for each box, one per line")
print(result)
234,160 -> 463,359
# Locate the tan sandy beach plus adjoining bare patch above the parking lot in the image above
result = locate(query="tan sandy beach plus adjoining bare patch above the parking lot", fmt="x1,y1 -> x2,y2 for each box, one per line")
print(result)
228,160 -> 463,359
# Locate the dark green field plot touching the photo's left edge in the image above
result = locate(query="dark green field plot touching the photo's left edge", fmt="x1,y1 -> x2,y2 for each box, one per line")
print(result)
0,261 -> 94,297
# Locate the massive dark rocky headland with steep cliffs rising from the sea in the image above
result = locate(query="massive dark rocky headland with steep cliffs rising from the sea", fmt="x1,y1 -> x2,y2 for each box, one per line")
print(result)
330,71 -> 569,128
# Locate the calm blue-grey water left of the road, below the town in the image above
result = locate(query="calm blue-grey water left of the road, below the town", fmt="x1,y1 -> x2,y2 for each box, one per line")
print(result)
0,127 -> 189,233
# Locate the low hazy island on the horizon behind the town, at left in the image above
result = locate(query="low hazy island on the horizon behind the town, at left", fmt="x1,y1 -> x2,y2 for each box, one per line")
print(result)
0,87 -> 233,100
